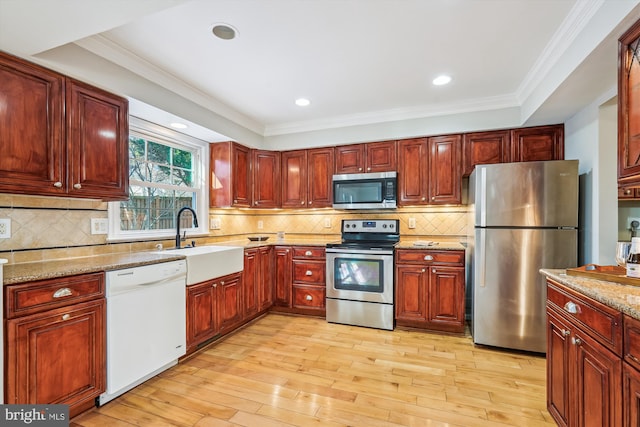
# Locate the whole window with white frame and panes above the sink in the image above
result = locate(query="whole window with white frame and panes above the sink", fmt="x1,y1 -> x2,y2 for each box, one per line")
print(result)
109,117 -> 208,240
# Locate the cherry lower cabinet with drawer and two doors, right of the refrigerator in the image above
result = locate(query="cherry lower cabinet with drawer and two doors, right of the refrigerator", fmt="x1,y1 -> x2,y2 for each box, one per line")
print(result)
547,281 -> 623,427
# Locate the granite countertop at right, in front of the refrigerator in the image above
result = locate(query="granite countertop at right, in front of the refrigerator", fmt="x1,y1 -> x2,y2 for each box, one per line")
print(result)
540,269 -> 640,320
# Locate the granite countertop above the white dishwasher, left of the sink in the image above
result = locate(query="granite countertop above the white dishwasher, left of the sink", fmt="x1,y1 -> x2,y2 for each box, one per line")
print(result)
3,252 -> 185,285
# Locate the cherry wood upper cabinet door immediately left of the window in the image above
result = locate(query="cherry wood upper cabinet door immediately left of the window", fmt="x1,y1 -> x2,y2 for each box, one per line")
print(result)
66,79 -> 129,200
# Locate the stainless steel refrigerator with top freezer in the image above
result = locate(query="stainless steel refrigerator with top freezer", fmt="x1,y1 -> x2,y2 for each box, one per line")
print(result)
468,160 -> 578,353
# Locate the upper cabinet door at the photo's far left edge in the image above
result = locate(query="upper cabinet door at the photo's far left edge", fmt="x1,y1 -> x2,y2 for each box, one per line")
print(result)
0,52 -> 67,195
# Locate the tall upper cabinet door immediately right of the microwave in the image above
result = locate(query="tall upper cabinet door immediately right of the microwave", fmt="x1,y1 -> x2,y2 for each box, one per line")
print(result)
398,138 -> 429,205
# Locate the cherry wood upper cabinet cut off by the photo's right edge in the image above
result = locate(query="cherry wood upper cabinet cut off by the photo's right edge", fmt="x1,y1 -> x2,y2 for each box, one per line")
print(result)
618,21 -> 640,187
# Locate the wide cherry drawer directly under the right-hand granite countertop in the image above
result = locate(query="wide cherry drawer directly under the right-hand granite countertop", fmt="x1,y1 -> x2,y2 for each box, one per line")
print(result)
547,280 -> 622,355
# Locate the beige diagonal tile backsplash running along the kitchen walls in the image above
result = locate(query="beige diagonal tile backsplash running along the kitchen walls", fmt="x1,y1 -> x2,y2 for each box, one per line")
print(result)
0,194 -> 468,263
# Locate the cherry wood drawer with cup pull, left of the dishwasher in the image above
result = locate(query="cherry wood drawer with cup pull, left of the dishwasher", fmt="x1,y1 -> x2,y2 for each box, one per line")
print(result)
5,273 -> 104,319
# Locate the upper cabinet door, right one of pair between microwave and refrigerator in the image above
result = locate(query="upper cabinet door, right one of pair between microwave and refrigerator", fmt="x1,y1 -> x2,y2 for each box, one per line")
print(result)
429,135 -> 462,204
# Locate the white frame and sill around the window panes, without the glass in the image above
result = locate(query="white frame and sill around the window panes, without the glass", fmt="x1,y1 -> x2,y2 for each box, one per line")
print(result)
107,116 -> 209,241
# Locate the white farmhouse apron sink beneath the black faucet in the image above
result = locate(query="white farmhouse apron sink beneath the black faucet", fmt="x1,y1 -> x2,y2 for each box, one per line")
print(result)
158,246 -> 244,285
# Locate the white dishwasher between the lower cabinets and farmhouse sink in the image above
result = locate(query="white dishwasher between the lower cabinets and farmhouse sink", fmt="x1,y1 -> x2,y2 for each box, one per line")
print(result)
99,261 -> 187,405
